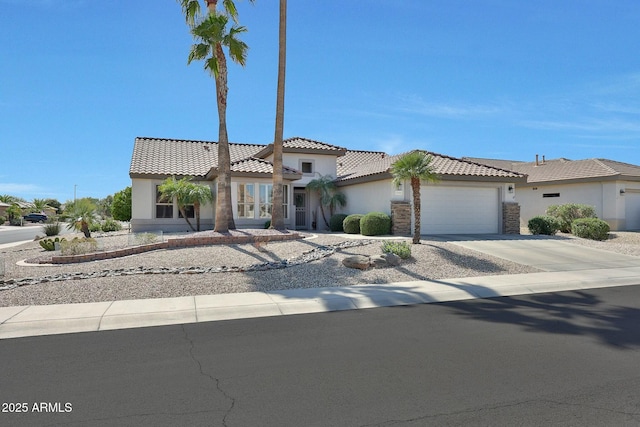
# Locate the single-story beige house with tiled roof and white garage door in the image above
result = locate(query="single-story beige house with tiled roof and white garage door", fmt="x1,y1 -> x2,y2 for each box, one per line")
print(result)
129,137 -> 526,234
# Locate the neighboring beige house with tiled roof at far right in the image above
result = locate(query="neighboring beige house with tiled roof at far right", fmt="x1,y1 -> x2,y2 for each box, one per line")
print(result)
467,157 -> 640,230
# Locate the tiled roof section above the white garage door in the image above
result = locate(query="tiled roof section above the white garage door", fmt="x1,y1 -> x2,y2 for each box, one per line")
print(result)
338,152 -> 524,181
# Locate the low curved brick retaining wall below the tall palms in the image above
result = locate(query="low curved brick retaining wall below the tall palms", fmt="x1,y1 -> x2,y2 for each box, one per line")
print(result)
45,233 -> 302,264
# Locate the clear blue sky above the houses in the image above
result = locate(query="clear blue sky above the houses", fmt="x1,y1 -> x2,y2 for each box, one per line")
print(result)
0,0 -> 640,202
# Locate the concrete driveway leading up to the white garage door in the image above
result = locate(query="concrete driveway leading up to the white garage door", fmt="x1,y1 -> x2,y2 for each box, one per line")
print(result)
429,234 -> 640,271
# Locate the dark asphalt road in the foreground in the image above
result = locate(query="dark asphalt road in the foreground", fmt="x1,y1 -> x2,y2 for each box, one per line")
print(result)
0,286 -> 640,427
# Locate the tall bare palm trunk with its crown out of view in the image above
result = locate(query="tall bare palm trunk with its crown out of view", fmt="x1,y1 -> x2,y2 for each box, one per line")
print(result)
270,0 -> 287,230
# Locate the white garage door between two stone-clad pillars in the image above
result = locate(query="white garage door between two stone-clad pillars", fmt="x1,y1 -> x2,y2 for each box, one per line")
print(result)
420,184 -> 500,234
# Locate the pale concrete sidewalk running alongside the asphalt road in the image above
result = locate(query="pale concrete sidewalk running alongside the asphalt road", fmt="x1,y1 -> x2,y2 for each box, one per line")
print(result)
0,266 -> 640,339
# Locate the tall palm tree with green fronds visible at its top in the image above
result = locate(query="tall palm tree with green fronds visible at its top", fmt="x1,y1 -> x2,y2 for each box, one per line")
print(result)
178,0 -> 253,232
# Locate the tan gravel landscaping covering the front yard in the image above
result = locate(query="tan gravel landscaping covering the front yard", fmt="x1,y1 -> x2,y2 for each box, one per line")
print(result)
0,233 -> 640,307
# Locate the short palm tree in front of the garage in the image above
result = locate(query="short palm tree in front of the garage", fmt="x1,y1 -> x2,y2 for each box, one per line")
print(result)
391,151 -> 439,244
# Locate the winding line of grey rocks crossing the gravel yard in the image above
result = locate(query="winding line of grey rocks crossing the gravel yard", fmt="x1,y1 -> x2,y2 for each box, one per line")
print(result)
0,241 -> 375,291
